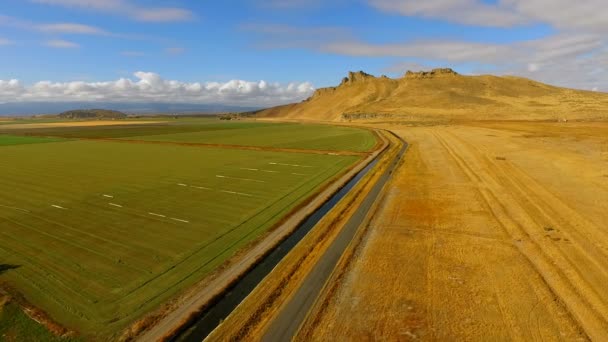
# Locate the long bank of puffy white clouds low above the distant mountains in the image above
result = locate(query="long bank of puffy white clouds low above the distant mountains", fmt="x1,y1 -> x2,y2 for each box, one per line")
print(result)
0,71 -> 314,106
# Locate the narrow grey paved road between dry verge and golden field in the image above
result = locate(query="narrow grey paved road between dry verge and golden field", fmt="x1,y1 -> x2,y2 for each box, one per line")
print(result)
262,133 -> 407,342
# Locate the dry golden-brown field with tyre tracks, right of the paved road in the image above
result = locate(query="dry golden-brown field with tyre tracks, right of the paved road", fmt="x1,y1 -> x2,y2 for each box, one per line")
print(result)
298,123 -> 608,341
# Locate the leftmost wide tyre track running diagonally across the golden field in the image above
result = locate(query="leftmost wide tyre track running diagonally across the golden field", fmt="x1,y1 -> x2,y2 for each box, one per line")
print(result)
433,131 -> 608,340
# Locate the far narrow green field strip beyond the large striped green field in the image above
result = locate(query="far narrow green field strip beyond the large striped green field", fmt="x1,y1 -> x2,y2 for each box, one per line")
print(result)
0,119 -> 376,152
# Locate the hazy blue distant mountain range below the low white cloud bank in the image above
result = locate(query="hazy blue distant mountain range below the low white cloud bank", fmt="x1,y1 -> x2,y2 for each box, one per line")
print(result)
0,102 -> 260,116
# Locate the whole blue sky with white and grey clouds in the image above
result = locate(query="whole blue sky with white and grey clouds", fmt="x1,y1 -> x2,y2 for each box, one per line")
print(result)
0,0 -> 608,105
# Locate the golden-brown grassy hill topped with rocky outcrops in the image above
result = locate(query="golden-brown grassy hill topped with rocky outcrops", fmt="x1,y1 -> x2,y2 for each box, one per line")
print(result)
257,69 -> 608,121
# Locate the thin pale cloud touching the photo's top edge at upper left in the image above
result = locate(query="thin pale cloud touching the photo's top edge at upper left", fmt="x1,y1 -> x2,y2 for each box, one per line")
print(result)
30,0 -> 194,22
